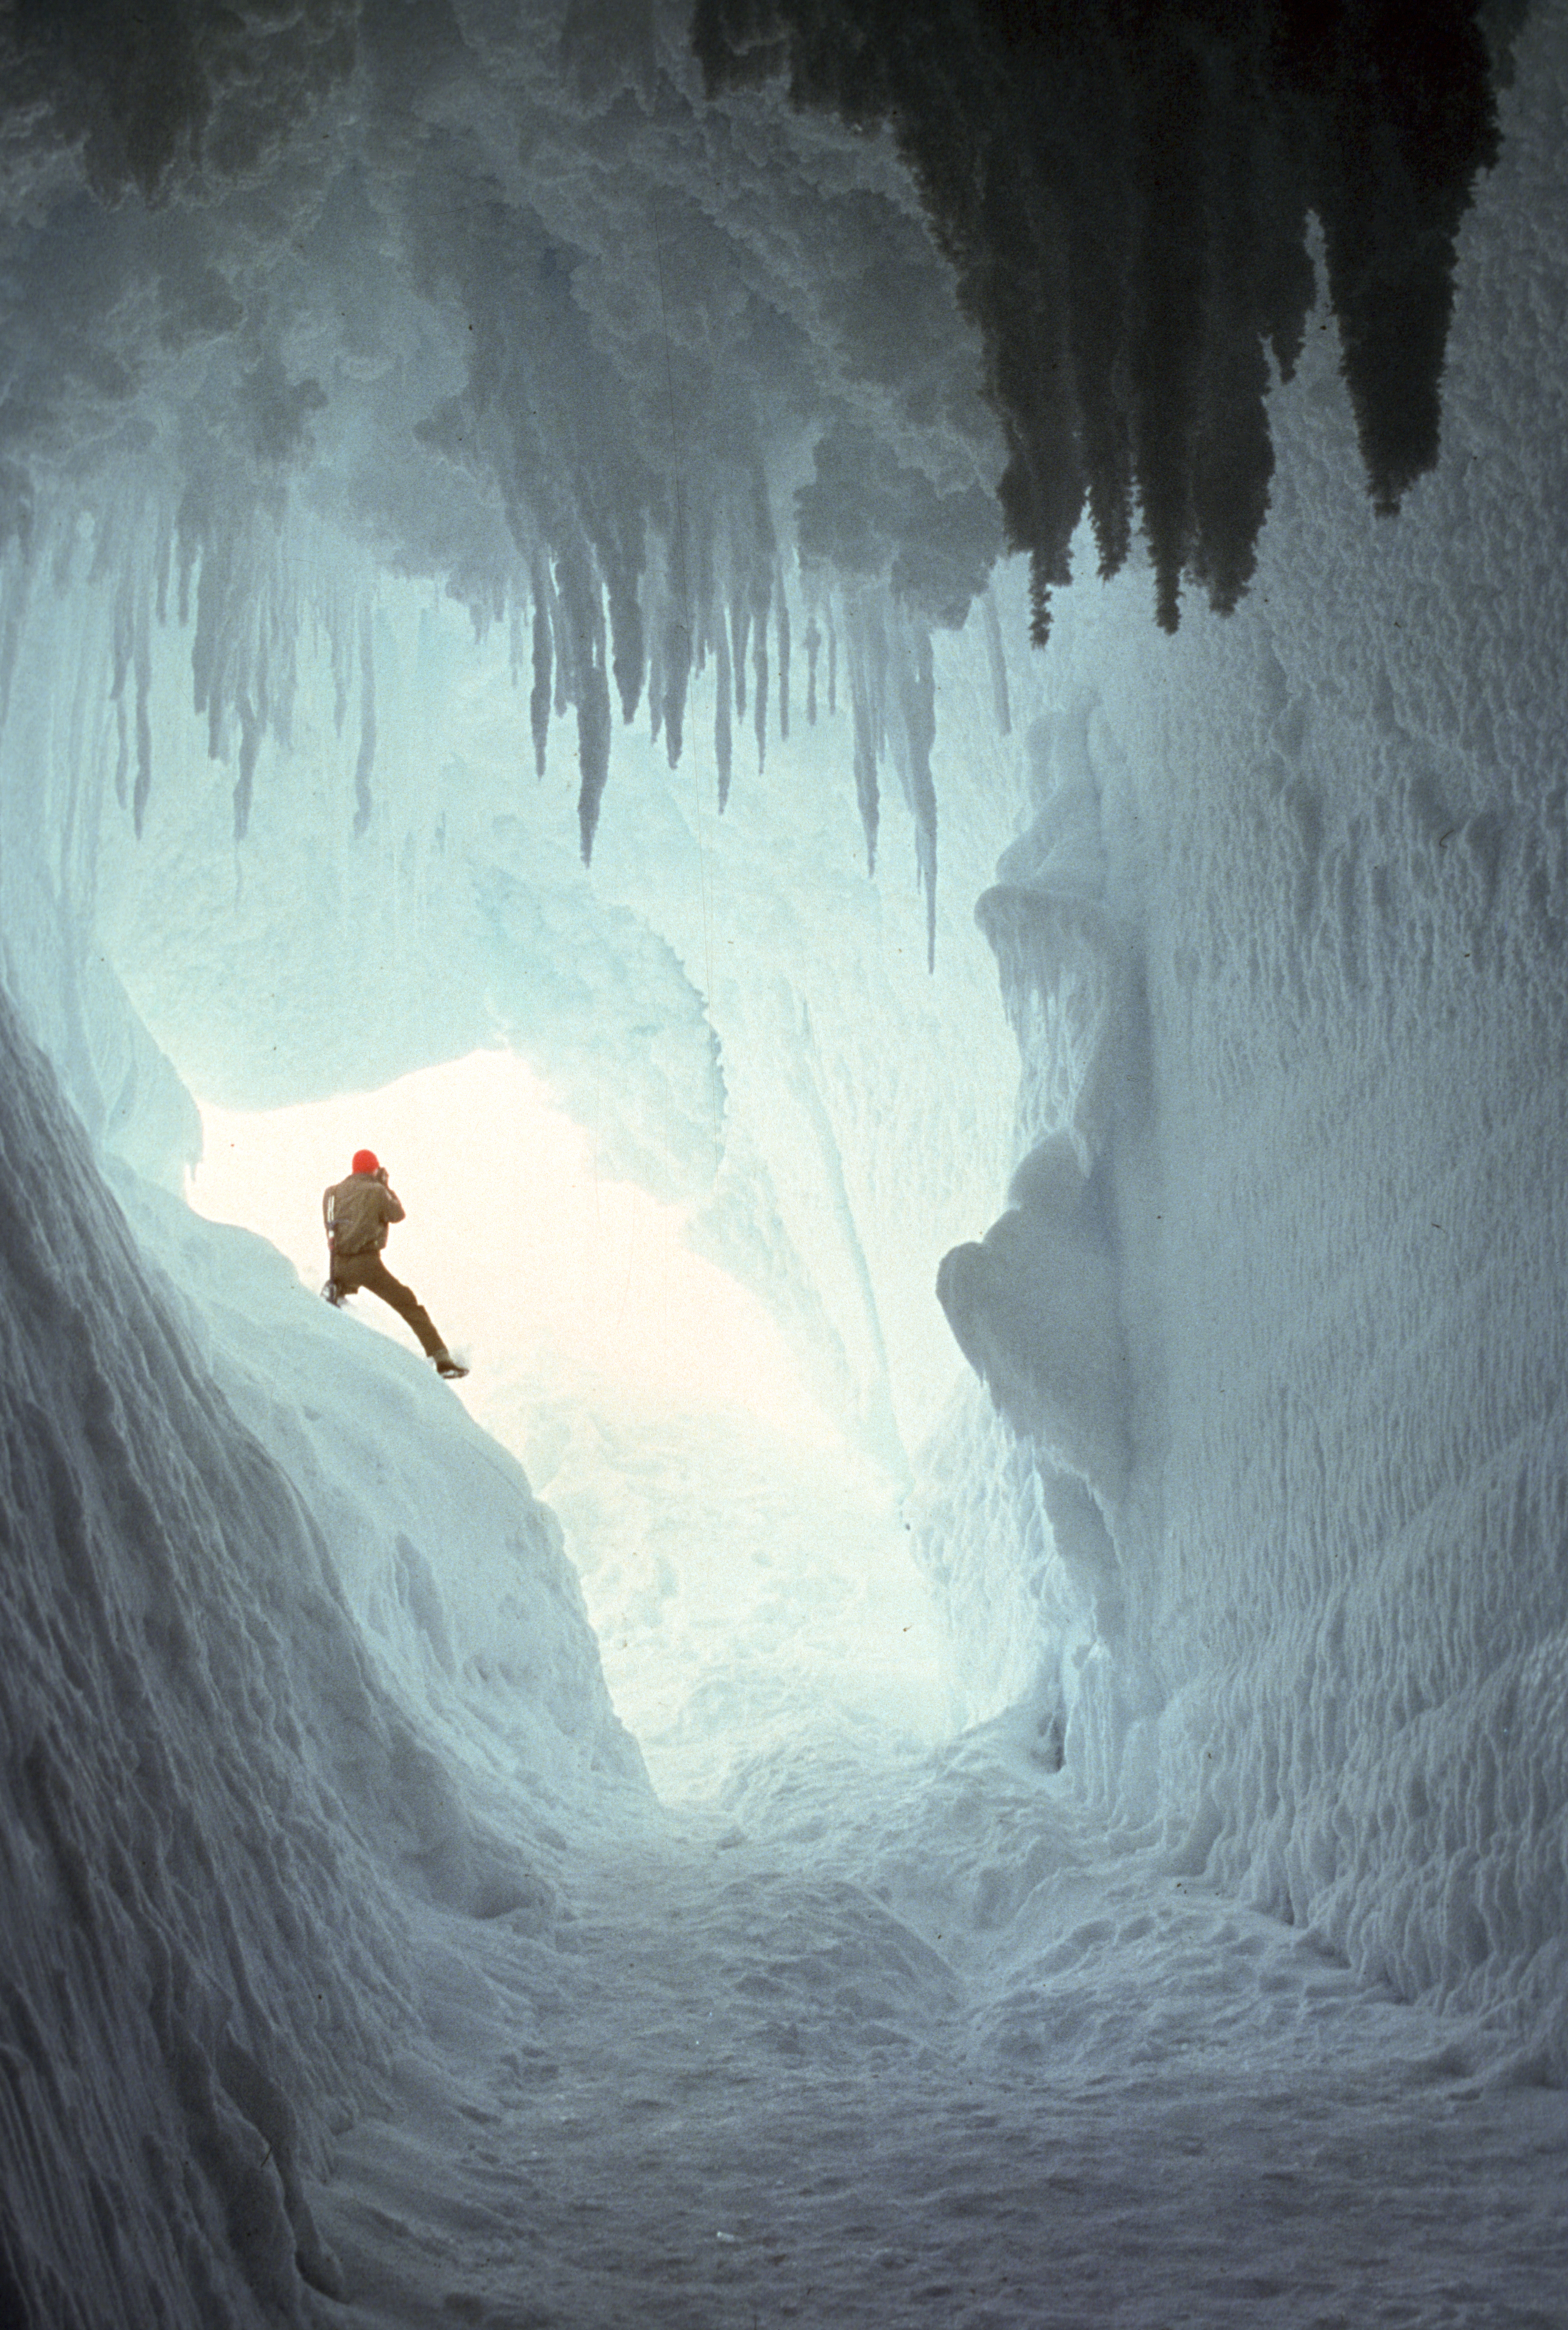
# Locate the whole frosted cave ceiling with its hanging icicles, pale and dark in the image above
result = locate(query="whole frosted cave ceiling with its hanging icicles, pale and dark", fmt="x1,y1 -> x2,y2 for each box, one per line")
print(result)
0,0 -> 1510,920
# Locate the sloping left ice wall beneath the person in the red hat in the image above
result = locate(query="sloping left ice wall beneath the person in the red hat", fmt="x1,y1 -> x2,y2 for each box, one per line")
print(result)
0,974 -> 641,2330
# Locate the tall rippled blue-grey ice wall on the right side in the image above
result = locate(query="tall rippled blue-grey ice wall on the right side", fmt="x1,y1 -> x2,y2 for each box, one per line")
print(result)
939,12 -> 1568,2074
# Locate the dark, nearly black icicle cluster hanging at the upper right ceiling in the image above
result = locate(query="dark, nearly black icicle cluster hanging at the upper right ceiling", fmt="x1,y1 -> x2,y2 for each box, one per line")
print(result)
692,0 -> 1522,641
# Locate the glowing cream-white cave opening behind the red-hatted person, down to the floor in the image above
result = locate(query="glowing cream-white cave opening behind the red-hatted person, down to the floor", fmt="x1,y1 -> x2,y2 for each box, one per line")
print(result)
189,1051 -> 955,1797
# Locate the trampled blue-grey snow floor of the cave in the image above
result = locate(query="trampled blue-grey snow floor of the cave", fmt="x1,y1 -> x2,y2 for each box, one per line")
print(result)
312,1717 -> 1568,2330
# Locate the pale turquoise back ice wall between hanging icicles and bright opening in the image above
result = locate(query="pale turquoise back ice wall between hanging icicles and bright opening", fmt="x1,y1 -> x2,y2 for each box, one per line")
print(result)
67,538 -> 1023,1477
